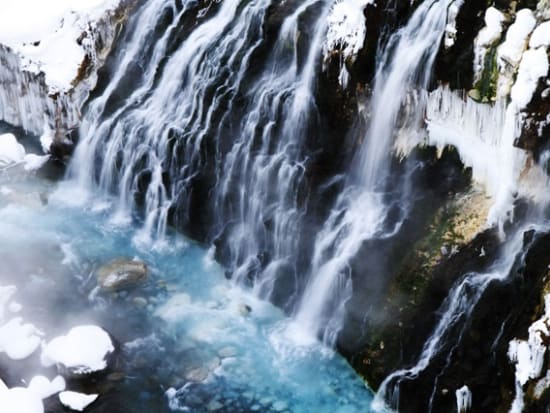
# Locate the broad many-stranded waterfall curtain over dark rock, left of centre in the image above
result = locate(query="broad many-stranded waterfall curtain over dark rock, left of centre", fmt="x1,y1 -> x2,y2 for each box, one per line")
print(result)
69,0 -> 331,305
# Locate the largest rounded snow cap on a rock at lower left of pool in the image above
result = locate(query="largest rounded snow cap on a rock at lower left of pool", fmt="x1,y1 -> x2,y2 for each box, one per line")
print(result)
41,325 -> 115,374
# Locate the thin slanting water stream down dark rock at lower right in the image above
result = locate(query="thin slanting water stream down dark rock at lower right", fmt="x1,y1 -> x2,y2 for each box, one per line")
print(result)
373,224 -> 548,411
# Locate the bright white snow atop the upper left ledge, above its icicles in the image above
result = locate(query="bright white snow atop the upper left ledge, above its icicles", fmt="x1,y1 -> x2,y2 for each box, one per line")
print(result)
0,0 -> 124,92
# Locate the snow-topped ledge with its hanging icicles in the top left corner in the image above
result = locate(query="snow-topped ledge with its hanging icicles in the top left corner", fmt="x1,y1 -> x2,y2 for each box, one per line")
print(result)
0,0 -> 135,137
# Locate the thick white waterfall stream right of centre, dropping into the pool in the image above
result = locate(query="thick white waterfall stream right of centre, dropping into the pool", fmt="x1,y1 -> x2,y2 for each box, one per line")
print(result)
296,0 -> 451,345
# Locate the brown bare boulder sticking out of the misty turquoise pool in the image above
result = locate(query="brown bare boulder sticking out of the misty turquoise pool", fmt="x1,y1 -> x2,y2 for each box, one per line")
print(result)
96,258 -> 149,291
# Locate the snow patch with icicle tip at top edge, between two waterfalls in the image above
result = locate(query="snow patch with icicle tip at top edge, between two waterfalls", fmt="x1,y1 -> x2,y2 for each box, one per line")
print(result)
324,0 -> 374,87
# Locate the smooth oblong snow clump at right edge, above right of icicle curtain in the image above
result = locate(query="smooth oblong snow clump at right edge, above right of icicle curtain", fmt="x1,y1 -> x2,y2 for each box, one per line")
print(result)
511,47 -> 548,110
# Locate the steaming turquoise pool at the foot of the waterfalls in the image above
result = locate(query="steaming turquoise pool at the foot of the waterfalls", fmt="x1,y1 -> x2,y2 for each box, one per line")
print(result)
0,159 -> 380,413
